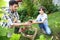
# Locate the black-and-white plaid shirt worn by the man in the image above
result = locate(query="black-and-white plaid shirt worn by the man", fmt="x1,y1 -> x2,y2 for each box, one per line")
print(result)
1,9 -> 20,27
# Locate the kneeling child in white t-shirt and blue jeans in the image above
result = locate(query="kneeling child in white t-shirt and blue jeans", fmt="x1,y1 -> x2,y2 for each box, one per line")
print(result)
33,6 -> 51,35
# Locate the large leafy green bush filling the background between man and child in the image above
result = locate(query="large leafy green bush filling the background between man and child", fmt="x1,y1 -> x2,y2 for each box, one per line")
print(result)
18,0 -> 38,22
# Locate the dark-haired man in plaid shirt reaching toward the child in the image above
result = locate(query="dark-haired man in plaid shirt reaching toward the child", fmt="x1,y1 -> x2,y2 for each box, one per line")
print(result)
2,1 -> 30,37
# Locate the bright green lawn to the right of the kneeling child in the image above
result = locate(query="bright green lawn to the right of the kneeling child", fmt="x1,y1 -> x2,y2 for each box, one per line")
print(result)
48,12 -> 60,34
